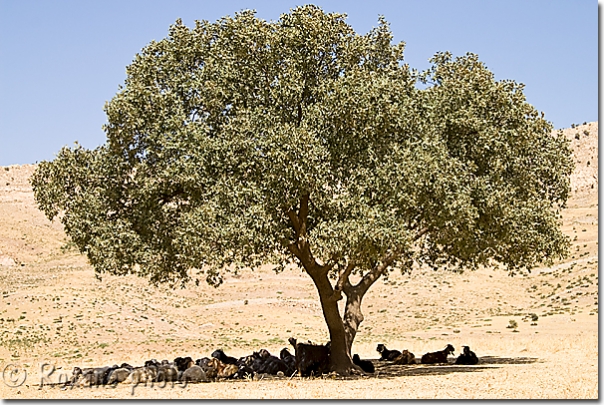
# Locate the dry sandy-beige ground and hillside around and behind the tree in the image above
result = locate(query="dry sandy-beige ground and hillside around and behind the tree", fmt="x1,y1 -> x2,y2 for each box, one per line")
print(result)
0,123 -> 598,398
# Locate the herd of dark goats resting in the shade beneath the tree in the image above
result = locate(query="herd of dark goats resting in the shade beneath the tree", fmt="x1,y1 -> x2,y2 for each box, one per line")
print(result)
68,338 -> 478,386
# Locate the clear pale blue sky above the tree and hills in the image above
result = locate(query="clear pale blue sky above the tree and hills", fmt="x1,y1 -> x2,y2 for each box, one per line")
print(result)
0,0 -> 600,166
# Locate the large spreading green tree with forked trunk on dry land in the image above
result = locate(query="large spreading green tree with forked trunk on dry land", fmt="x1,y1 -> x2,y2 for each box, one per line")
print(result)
32,6 -> 573,373
